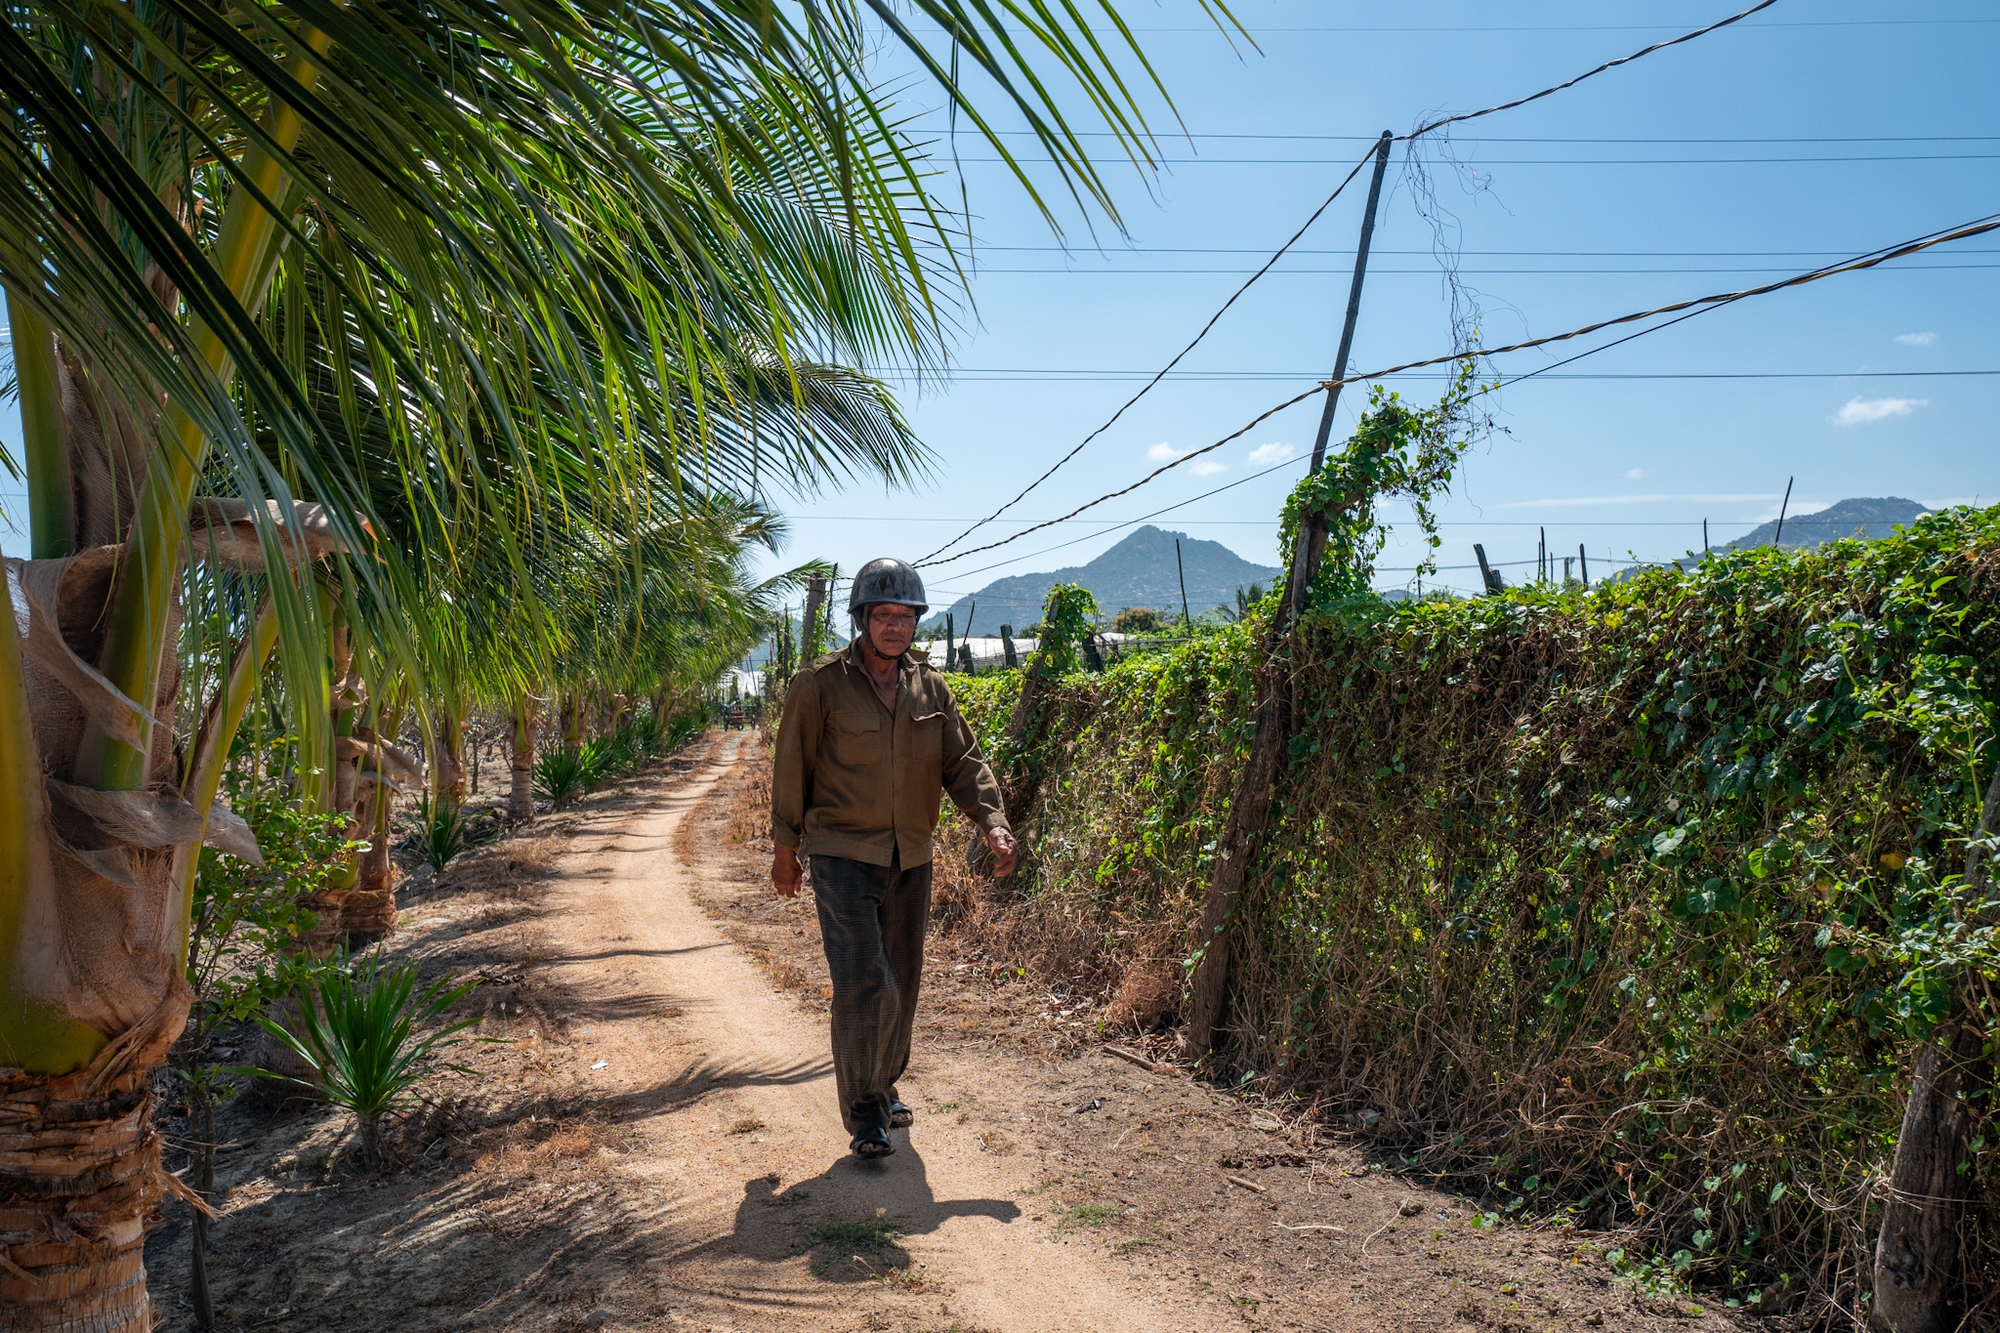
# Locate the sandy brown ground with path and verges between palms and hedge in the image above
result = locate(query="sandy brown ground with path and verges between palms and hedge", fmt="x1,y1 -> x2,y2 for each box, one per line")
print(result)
148,735 -> 1724,1333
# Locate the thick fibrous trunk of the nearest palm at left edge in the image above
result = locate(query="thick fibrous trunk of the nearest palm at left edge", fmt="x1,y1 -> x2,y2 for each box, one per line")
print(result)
0,39 -> 330,1333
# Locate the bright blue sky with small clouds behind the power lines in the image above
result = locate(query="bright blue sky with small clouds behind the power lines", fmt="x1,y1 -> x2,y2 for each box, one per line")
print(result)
0,0 -> 2000,602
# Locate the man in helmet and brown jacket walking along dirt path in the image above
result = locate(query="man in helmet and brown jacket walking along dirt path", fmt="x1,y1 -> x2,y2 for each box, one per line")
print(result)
770,558 -> 1014,1159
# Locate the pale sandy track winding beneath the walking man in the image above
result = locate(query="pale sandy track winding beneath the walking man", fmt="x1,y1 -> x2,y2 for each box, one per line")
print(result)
542,735 -> 1216,1333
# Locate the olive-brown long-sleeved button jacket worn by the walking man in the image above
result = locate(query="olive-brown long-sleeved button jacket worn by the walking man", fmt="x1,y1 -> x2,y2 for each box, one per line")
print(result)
770,644 -> 1008,869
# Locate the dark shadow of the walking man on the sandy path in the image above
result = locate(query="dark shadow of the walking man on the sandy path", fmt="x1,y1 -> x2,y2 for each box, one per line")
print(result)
734,1143 -> 1020,1283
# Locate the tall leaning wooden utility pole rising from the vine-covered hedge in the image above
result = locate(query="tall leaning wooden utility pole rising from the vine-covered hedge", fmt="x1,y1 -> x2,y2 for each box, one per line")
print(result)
1180,130 -> 1396,1061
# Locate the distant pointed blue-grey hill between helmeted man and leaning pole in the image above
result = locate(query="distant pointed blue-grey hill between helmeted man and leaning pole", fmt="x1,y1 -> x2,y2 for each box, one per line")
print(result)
924,524 -> 1284,634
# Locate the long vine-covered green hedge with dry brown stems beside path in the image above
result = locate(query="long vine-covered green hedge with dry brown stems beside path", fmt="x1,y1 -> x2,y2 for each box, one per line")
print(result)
960,510 -> 2000,1309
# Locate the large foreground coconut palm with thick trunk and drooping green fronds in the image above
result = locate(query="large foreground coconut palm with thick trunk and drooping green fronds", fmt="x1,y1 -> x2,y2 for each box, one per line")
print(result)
0,0 -> 1232,1329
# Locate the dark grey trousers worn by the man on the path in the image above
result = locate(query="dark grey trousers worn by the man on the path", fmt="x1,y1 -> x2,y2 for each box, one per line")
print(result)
812,857 -> 930,1135
